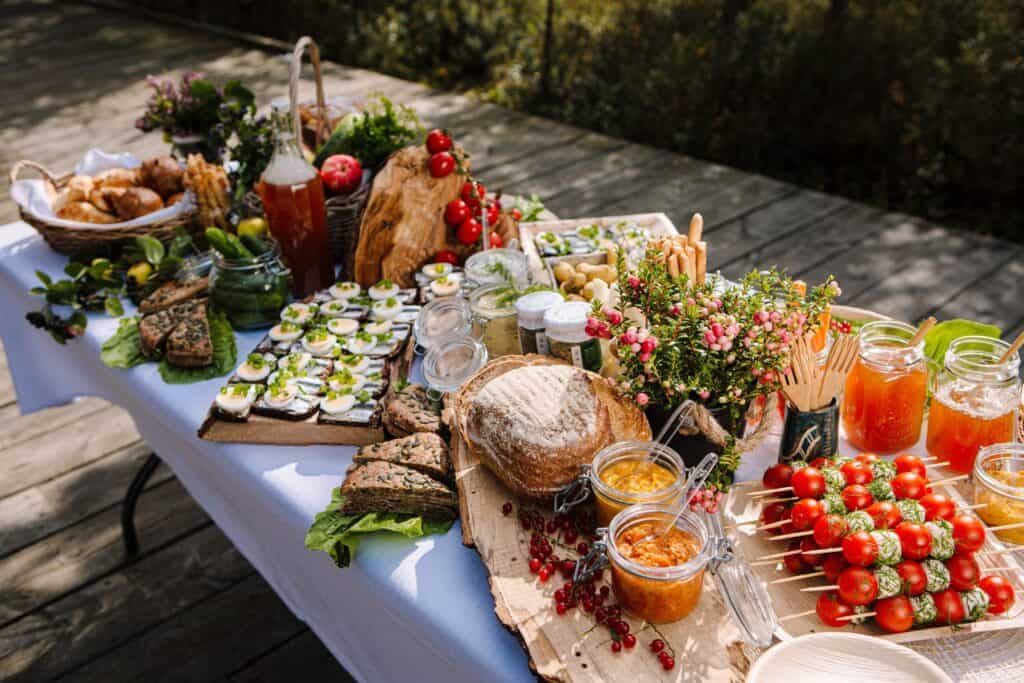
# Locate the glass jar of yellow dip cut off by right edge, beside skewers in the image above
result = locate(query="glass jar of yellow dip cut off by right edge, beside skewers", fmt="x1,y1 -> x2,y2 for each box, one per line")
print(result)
973,443 -> 1024,545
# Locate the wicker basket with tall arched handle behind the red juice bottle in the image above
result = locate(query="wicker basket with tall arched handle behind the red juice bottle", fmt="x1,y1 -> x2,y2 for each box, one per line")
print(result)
244,36 -> 372,280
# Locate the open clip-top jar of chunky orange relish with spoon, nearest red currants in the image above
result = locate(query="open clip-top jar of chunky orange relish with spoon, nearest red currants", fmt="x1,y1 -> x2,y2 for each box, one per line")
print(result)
606,505 -> 714,624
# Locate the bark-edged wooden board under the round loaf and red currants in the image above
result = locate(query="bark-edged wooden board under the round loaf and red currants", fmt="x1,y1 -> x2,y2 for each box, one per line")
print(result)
452,430 -> 753,683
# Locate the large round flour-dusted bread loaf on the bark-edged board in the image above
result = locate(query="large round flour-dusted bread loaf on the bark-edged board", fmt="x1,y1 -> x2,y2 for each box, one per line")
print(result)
454,355 -> 650,500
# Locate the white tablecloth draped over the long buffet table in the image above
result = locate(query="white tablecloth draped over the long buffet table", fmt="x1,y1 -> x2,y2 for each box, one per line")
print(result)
0,223 -> 535,683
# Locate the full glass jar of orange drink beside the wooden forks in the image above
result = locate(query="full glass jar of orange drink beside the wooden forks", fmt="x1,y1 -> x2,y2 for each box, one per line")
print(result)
841,321 -> 928,454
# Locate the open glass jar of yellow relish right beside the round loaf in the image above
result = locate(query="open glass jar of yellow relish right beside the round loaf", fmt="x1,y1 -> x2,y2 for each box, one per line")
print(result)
590,441 -> 686,526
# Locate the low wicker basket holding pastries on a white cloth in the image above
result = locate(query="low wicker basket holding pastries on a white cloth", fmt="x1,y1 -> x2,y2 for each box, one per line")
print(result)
8,160 -> 198,258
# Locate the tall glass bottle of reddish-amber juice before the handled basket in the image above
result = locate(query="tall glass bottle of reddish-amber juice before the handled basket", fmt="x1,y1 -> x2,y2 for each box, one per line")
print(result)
256,102 -> 334,298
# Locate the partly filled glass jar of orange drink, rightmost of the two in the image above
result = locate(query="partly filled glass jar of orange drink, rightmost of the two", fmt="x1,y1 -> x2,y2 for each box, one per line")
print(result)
928,337 -> 1021,473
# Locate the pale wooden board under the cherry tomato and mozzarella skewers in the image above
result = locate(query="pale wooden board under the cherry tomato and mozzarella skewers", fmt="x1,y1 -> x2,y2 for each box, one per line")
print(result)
723,481 -> 1024,643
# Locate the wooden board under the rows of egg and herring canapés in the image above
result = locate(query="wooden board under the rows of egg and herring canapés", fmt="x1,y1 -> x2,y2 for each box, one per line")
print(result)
199,334 -> 416,445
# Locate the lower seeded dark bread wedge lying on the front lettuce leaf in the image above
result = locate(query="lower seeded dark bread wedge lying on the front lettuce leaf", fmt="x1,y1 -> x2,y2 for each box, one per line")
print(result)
341,461 -> 459,519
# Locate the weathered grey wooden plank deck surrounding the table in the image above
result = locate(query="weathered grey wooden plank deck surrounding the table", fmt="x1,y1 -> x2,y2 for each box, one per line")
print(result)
0,0 -> 1024,683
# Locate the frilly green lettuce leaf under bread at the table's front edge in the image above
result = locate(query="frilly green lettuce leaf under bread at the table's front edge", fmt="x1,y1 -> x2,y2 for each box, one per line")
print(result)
306,488 -> 453,567
